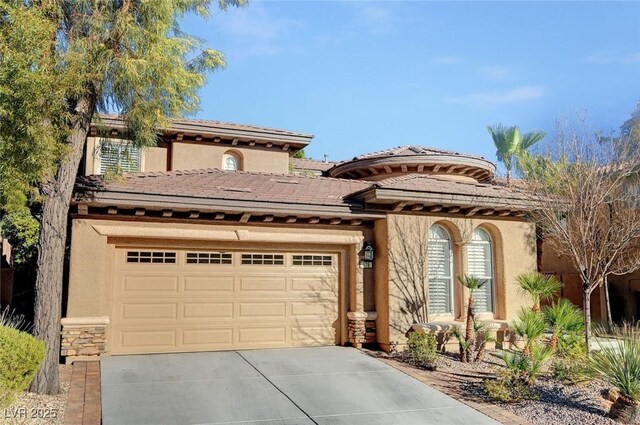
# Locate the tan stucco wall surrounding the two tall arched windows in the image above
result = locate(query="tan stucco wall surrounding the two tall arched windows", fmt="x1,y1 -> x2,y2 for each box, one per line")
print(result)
375,214 -> 536,348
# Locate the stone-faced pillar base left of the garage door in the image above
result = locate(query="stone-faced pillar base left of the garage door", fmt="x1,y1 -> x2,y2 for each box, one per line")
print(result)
60,317 -> 109,362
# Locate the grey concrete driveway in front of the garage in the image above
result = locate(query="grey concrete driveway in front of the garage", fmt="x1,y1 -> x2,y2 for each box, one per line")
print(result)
101,347 -> 498,425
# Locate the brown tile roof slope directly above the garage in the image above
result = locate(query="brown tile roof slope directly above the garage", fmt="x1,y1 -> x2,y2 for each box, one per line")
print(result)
76,169 -> 371,206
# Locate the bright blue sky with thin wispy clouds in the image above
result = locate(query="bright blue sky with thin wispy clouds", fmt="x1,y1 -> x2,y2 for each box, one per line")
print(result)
184,1 -> 640,171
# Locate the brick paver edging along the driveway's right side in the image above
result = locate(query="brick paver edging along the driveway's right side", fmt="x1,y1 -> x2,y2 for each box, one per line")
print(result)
373,356 -> 532,425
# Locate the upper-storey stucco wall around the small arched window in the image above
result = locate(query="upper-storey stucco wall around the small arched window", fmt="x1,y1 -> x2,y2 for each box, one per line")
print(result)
172,142 -> 289,174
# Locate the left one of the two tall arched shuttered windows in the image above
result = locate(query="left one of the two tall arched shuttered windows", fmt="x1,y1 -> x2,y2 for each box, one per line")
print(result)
427,224 -> 453,314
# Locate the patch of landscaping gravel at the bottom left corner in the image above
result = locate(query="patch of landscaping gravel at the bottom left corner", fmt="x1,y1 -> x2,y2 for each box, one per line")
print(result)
0,365 -> 71,425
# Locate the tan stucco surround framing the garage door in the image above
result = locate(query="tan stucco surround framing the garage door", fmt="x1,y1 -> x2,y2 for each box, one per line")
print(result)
65,219 -> 374,353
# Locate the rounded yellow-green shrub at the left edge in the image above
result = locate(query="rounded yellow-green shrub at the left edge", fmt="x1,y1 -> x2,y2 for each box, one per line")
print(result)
0,326 -> 45,409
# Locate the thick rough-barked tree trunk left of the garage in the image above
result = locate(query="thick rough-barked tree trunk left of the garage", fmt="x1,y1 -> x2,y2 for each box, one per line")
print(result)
30,99 -> 95,394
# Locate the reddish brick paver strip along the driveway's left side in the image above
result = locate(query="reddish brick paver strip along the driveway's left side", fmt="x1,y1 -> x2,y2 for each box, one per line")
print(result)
64,361 -> 102,425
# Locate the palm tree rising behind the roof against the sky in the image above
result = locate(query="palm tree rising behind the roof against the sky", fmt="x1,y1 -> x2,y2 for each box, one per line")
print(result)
487,124 -> 546,183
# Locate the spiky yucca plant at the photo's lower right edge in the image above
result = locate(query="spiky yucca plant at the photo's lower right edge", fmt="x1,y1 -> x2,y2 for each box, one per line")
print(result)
591,324 -> 640,423
